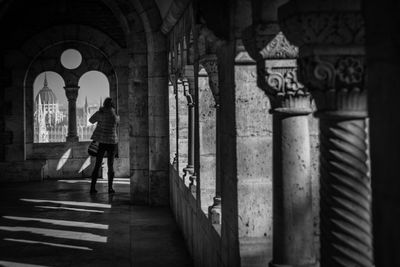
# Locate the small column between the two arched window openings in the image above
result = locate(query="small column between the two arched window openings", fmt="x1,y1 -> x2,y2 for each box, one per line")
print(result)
64,85 -> 79,142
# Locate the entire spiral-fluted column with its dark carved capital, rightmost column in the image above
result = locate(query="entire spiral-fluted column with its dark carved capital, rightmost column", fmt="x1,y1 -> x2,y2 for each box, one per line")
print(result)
279,0 -> 374,267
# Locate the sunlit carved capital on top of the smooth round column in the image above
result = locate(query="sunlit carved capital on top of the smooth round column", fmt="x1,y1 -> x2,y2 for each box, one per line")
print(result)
244,23 -> 311,114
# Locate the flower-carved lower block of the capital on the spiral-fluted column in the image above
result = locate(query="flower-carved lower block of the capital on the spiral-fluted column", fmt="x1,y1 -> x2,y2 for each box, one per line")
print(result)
299,55 -> 367,114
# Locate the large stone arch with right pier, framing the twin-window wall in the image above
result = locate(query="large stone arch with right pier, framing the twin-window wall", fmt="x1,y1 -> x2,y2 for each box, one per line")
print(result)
0,0 -> 169,205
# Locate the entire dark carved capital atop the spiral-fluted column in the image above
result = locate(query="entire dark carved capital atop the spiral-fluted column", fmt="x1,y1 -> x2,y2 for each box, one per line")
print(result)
279,0 -> 367,118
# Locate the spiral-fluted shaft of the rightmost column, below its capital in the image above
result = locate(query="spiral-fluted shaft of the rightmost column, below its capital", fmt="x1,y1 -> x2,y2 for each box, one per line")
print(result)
320,117 -> 373,267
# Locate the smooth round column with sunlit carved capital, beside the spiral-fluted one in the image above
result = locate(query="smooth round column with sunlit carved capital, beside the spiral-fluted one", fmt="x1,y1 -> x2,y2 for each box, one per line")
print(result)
248,29 -> 316,267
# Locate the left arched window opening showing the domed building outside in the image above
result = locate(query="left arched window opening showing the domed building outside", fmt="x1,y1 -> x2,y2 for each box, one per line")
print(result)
33,71 -> 68,143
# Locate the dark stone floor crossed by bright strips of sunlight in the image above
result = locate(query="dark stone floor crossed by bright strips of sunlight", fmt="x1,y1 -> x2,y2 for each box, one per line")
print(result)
0,179 -> 192,267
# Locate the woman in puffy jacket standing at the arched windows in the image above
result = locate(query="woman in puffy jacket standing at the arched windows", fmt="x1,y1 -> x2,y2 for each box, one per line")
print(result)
89,97 -> 119,194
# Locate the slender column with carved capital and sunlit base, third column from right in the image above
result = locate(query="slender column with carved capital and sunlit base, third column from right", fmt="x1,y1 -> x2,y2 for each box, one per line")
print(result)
200,54 -> 222,224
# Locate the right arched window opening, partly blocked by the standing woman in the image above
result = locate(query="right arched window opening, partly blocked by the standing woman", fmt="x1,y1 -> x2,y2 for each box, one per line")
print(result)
76,71 -> 110,141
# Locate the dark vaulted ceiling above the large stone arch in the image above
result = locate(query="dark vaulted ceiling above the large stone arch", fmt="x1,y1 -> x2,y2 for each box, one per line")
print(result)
0,0 -> 126,47
